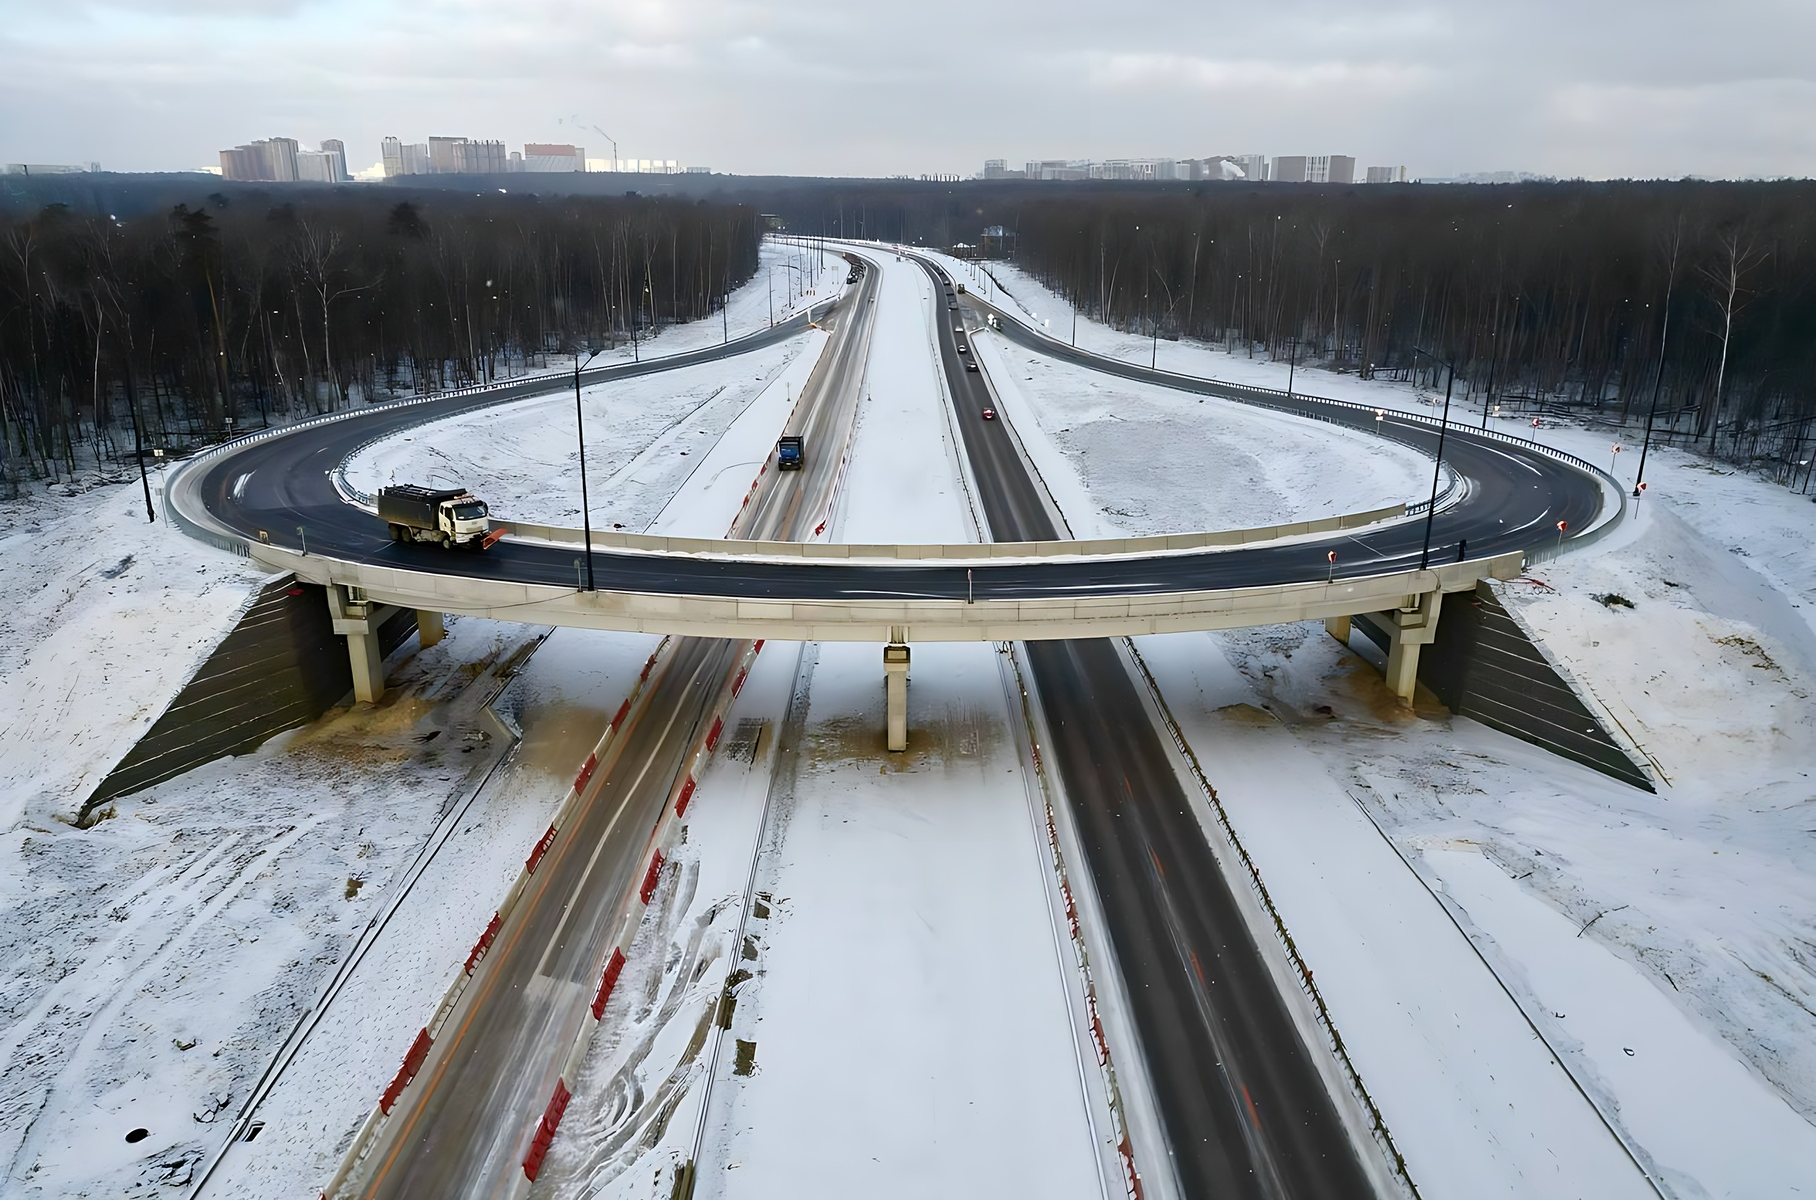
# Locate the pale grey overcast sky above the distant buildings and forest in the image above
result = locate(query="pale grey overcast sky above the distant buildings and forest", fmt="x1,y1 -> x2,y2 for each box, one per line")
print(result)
0,0 -> 1816,178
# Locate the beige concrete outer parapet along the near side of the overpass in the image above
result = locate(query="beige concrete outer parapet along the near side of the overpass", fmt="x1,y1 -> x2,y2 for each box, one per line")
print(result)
263,546 -> 1522,643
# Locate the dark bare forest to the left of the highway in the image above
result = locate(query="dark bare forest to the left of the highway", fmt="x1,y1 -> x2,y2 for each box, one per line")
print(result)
0,189 -> 763,497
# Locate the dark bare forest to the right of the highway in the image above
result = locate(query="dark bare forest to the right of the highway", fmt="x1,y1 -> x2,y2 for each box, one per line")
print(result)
777,182 -> 1816,479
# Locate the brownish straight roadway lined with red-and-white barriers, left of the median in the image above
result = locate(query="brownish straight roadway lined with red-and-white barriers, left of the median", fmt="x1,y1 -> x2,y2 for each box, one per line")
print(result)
338,257 -> 875,1200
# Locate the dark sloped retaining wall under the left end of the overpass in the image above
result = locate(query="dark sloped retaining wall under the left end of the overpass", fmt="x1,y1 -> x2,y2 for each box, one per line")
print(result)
80,574 -> 416,821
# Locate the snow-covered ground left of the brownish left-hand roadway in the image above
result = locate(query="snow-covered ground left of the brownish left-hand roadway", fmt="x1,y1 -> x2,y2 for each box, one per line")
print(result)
0,251 -> 844,1196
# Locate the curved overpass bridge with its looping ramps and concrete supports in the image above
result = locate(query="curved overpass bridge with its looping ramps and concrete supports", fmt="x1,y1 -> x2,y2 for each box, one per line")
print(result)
165,261 -> 1625,744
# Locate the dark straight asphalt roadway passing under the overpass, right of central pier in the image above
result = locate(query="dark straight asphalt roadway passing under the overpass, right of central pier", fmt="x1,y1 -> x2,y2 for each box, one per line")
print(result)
930,257 -> 1373,1200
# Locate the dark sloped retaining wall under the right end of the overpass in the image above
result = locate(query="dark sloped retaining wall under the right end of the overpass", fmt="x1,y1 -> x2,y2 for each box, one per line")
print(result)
1357,579 -> 1654,792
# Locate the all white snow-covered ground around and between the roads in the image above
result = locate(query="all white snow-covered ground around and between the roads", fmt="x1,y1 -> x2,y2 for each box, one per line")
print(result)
14,231 -> 1816,1200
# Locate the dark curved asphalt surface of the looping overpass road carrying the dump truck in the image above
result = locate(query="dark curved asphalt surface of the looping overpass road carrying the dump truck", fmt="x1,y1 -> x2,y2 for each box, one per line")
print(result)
180,295 -> 1602,599
